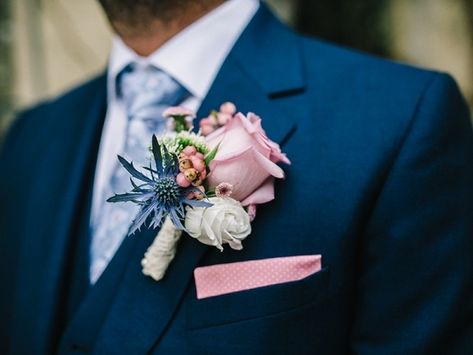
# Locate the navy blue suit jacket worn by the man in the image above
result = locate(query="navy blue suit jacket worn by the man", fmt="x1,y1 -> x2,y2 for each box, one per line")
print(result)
0,6 -> 473,355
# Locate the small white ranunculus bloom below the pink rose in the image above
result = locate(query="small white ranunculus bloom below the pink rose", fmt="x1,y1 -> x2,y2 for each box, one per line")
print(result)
185,197 -> 251,250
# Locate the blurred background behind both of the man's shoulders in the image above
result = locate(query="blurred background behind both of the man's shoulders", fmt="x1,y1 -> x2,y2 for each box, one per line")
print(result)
0,0 -> 473,133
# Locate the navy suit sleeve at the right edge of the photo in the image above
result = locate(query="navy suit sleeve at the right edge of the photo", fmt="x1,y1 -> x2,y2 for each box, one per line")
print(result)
350,74 -> 473,355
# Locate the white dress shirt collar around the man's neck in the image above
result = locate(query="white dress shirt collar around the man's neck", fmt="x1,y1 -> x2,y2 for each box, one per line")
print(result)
108,0 -> 259,101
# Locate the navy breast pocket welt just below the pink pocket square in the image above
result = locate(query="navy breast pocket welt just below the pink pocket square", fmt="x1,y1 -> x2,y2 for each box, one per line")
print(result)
186,268 -> 330,330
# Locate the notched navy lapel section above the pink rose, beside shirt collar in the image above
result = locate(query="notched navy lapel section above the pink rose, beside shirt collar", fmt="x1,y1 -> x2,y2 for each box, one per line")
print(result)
197,4 -> 306,145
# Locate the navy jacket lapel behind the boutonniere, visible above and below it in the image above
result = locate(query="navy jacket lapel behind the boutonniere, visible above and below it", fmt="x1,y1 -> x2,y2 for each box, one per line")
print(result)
71,5 -> 304,354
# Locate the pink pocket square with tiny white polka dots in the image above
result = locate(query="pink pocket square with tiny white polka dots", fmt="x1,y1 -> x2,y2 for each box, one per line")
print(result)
194,255 -> 322,299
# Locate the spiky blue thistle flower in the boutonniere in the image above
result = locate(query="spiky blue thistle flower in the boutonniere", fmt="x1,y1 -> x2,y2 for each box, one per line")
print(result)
107,135 -> 212,235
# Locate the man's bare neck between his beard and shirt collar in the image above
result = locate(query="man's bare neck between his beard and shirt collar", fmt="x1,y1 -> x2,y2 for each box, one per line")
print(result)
112,0 -> 224,57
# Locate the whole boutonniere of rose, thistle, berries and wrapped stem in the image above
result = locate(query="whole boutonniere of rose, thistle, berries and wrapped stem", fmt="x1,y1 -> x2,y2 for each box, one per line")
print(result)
107,102 -> 290,281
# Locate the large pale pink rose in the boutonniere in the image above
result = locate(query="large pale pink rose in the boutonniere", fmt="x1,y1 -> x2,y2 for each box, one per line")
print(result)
206,113 -> 290,206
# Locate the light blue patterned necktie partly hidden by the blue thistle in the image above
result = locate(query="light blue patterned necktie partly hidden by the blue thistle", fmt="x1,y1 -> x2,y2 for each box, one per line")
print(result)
90,63 -> 189,284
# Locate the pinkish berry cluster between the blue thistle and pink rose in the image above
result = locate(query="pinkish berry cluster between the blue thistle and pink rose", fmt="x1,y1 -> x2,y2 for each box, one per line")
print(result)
176,146 -> 207,191
